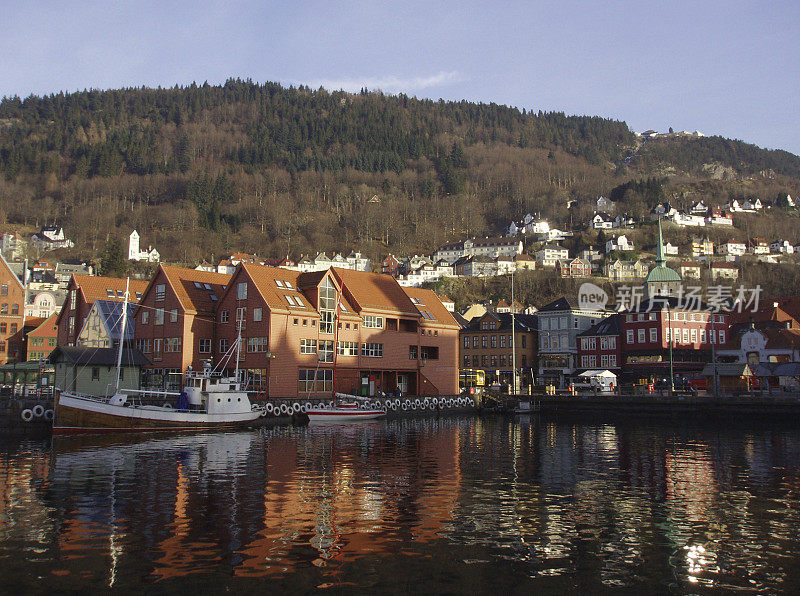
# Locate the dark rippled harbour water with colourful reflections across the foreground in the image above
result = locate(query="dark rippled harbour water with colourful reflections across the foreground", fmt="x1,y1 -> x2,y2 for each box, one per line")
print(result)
0,418 -> 800,593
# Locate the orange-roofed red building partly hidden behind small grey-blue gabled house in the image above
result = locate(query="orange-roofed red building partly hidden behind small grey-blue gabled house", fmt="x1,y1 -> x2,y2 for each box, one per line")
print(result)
56,274 -> 147,346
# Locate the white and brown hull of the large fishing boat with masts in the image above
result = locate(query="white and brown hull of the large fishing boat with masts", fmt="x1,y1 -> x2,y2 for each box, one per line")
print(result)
53,395 -> 260,435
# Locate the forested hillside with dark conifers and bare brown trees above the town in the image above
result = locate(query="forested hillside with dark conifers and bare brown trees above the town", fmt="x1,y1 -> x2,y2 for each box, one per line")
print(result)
0,80 -> 800,262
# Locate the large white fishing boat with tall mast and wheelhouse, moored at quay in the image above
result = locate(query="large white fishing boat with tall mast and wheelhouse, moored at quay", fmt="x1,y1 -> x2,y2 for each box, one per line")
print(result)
53,280 -> 261,434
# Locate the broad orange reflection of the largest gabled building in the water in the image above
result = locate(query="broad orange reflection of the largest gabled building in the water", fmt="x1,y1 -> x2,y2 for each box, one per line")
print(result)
236,420 -> 461,576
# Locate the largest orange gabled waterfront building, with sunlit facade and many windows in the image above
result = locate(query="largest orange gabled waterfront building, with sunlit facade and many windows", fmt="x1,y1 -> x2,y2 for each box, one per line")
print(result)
214,262 -> 459,397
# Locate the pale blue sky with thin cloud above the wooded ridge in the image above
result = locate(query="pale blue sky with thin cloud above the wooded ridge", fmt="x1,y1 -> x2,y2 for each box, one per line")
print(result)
0,0 -> 800,154
